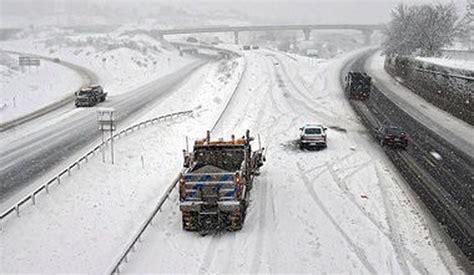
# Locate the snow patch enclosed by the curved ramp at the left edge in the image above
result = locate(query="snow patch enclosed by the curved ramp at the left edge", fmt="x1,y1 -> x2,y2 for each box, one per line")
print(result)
0,53 -> 84,123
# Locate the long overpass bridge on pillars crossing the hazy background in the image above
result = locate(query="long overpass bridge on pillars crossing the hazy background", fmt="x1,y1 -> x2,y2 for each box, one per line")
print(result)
151,24 -> 383,44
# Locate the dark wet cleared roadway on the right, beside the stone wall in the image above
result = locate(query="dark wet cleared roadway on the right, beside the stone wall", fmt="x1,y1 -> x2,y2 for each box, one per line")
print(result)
345,50 -> 474,260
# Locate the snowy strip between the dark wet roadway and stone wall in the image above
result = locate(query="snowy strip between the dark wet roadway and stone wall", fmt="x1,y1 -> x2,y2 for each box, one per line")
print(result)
366,52 -> 474,155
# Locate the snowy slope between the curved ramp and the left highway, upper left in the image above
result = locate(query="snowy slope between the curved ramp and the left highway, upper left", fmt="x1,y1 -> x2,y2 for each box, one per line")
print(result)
0,31 -> 194,96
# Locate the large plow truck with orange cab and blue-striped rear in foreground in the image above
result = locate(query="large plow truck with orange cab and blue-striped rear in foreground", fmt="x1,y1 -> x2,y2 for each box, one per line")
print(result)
179,130 -> 265,236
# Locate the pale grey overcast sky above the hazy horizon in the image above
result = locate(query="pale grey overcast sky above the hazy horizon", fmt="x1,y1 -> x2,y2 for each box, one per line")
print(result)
0,0 -> 467,27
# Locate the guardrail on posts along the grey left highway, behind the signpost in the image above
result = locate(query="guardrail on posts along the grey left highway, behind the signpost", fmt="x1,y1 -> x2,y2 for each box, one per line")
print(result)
0,110 -> 193,225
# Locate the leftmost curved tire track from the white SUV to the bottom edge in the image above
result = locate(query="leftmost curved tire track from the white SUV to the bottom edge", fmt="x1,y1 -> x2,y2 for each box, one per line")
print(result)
296,162 -> 377,274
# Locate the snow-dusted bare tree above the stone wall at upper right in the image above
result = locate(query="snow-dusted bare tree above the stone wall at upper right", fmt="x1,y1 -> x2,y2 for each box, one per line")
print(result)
383,4 -> 467,56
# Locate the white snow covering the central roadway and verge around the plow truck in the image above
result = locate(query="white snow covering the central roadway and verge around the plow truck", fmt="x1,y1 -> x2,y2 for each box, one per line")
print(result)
0,50 -> 462,274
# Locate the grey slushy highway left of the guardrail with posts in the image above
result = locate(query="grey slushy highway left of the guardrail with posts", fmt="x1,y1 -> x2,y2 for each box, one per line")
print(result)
0,60 -> 207,202
